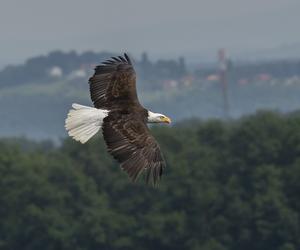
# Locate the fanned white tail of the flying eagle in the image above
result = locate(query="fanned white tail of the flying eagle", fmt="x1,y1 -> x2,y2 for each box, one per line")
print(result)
65,103 -> 108,143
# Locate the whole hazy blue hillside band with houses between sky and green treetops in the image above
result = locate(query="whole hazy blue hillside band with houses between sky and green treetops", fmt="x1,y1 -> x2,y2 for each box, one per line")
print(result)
0,51 -> 300,138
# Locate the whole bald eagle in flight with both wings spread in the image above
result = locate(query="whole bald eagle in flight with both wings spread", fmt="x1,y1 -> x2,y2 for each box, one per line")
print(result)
65,53 -> 171,185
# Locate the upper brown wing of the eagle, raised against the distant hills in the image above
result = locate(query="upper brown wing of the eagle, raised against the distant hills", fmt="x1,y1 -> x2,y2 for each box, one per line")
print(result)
89,54 -> 139,110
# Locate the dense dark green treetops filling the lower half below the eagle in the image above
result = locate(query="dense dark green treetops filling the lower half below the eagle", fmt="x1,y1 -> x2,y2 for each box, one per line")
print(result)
0,112 -> 300,250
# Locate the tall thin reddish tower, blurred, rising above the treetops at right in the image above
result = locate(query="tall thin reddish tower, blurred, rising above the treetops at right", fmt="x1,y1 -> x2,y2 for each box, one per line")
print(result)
218,49 -> 229,119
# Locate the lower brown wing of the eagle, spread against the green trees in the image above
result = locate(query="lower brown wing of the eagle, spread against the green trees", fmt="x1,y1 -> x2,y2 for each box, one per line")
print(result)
102,112 -> 165,185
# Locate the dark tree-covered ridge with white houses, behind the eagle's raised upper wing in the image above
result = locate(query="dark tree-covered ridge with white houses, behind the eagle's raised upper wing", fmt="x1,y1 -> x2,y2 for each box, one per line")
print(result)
0,51 -> 186,88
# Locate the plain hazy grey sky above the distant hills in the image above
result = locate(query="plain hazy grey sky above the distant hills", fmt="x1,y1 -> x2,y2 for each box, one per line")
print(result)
0,0 -> 300,65
